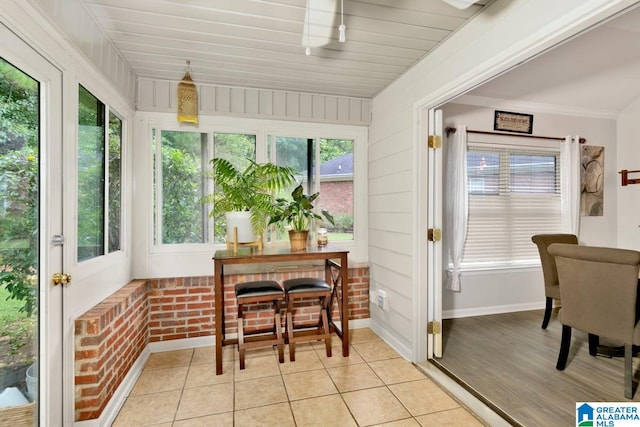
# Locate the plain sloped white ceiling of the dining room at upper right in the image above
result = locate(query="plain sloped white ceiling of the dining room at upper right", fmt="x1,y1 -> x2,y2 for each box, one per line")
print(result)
461,4 -> 640,117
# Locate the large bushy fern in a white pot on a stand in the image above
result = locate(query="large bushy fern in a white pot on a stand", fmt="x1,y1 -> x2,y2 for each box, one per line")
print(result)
203,157 -> 295,243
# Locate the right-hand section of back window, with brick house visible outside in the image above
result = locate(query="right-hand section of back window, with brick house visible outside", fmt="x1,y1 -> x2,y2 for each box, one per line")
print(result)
275,137 -> 354,241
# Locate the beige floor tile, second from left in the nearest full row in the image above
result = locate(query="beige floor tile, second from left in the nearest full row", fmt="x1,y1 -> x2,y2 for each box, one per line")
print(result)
176,383 -> 233,420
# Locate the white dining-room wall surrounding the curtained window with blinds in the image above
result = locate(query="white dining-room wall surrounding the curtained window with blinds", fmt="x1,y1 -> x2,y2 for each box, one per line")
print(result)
442,101 -> 619,318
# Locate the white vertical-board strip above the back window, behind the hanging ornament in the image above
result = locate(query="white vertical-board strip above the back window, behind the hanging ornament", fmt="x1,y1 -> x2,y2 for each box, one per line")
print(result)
137,76 -> 371,125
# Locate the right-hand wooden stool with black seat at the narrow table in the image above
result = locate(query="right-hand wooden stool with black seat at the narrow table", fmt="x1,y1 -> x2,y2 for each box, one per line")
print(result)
282,277 -> 331,362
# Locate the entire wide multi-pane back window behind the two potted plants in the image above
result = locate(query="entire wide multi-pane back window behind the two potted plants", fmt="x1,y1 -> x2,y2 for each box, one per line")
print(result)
151,127 -> 354,246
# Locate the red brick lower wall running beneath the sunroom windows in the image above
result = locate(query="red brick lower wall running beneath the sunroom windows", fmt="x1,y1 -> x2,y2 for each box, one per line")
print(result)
74,267 -> 369,421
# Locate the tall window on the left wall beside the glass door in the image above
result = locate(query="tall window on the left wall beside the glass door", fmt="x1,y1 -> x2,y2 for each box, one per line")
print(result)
77,86 -> 122,261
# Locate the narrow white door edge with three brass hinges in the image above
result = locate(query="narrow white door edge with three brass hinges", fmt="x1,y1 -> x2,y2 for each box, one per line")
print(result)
427,109 -> 444,359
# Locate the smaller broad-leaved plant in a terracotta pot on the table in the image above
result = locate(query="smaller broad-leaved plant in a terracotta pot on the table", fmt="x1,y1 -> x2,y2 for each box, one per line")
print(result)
269,184 -> 335,251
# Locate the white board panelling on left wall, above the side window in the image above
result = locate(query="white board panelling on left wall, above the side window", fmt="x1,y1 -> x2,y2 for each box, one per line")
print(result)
30,0 -> 136,105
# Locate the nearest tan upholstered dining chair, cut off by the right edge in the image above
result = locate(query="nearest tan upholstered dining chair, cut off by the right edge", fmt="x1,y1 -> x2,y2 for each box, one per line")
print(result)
549,243 -> 640,399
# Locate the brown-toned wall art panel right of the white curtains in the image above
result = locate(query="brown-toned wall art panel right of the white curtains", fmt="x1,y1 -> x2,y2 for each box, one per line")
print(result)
580,145 -> 604,216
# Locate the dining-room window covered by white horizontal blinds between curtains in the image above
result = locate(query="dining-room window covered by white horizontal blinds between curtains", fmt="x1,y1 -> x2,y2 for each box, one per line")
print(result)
463,146 -> 561,267
